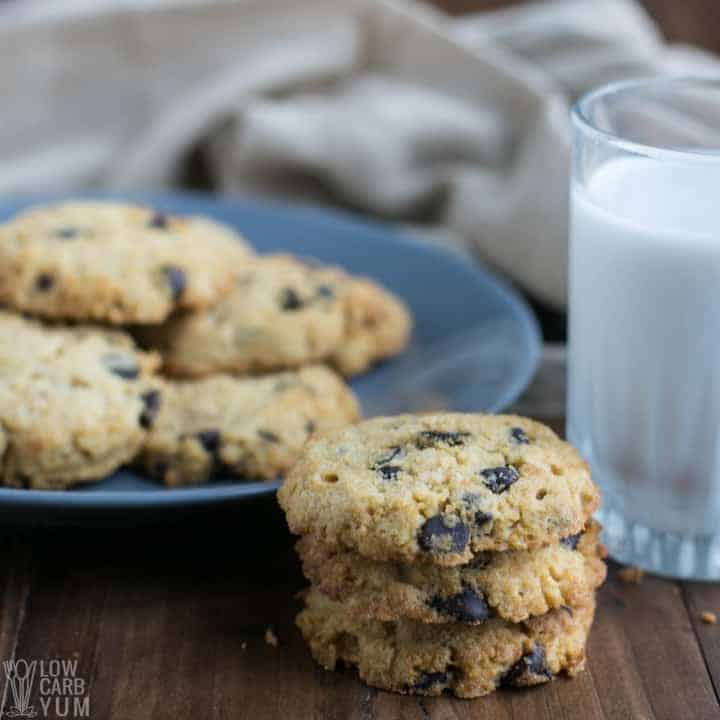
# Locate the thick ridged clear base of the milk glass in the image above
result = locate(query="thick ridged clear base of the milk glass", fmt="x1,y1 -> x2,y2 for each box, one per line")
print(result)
598,504 -> 720,581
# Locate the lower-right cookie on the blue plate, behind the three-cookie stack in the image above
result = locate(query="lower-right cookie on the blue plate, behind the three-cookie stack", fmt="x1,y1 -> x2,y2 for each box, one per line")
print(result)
141,366 -> 360,485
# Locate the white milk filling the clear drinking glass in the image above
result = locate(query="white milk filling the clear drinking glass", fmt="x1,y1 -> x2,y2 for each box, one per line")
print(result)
568,158 -> 720,534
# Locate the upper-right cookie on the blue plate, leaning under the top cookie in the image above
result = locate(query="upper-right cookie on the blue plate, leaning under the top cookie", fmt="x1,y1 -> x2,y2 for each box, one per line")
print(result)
147,255 -> 411,377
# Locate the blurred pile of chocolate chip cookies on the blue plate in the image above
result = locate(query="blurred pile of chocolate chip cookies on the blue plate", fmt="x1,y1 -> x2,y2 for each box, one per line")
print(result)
0,202 -> 410,489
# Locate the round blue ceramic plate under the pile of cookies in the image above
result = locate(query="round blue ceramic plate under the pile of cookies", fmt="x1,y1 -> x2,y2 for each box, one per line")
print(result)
0,193 -> 540,522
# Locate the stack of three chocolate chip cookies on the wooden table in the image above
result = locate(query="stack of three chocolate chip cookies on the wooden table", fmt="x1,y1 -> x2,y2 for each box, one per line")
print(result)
279,413 -> 605,697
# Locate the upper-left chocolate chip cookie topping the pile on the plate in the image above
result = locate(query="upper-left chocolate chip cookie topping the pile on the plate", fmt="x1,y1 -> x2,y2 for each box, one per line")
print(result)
0,202 -> 251,324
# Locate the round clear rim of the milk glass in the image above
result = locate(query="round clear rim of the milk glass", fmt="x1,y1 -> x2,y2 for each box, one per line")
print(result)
570,75 -> 720,163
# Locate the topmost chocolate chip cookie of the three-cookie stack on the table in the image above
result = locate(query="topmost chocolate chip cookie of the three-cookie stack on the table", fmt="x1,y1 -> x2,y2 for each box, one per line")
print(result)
278,413 -> 599,566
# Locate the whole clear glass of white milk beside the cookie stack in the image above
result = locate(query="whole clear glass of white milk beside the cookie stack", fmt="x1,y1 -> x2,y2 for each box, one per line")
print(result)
567,79 -> 720,580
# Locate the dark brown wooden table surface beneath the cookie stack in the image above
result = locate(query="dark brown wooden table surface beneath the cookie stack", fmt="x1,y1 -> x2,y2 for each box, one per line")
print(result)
0,348 -> 720,720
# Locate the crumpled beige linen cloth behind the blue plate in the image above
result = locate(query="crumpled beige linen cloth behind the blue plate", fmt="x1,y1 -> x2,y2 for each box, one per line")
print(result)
0,0 -> 720,307
